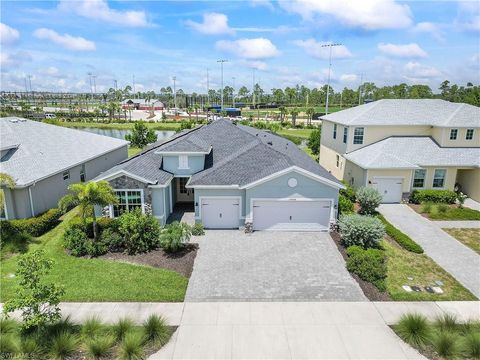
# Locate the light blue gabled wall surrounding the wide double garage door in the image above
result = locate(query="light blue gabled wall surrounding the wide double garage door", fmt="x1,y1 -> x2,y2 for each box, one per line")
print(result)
245,171 -> 338,218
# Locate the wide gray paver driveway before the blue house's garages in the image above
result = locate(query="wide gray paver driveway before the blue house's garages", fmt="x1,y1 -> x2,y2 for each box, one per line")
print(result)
185,230 -> 366,301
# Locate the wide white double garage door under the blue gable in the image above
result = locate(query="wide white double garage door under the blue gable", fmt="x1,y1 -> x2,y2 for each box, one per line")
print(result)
253,199 -> 332,231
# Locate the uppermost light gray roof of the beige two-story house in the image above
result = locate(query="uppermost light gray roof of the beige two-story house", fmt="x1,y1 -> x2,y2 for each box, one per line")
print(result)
321,99 -> 480,127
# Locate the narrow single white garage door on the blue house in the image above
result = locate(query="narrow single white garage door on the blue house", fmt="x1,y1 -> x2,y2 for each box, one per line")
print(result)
201,198 -> 240,229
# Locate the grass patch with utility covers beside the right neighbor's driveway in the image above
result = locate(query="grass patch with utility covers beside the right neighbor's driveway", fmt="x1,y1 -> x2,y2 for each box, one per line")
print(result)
382,239 -> 477,301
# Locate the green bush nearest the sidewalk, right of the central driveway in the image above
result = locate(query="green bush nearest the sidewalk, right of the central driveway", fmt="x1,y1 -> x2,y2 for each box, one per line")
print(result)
347,246 -> 387,291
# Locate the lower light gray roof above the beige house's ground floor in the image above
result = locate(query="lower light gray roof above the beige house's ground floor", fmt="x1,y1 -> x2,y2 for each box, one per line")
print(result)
345,136 -> 480,169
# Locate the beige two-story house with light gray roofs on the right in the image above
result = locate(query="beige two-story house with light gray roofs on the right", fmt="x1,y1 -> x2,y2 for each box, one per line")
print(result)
320,99 -> 480,203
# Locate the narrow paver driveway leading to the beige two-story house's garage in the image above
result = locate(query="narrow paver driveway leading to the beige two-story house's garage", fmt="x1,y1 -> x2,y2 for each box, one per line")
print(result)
379,204 -> 480,297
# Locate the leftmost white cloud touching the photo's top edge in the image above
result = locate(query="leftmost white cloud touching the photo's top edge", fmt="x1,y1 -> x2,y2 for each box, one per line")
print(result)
58,0 -> 148,27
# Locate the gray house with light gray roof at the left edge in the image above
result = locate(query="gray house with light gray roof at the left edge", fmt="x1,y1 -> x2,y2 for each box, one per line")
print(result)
0,117 -> 128,219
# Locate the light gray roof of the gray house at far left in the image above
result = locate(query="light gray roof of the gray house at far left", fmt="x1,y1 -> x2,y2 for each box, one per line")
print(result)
0,117 -> 128,187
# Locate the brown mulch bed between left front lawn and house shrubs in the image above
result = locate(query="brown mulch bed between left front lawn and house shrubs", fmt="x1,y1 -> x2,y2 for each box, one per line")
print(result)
99,244 -> 198,278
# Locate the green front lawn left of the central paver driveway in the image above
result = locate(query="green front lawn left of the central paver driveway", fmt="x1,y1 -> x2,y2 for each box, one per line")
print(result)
0,211 -> 188,302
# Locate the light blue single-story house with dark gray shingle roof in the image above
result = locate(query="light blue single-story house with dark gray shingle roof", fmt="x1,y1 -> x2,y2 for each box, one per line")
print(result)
95,119 -> 343,231
